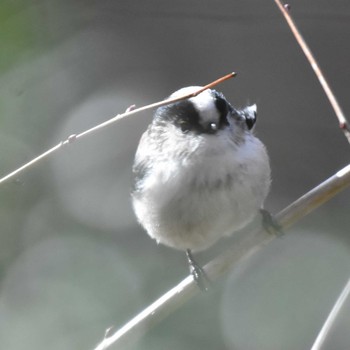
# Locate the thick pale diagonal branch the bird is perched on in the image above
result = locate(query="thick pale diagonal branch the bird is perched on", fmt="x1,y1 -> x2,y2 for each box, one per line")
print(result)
95,164 -> 350,350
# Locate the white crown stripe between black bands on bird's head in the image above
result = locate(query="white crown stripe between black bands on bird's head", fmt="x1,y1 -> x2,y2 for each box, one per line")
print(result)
170,86 -> 219,122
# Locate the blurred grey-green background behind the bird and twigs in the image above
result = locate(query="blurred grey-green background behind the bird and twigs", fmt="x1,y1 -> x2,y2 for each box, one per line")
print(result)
0,0 -> 350,350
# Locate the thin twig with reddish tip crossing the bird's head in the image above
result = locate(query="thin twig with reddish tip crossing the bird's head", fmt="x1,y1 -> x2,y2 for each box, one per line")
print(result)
0,72 -> 236,184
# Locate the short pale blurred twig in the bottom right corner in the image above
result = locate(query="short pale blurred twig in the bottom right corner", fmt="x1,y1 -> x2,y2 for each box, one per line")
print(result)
311,279 -> 350,350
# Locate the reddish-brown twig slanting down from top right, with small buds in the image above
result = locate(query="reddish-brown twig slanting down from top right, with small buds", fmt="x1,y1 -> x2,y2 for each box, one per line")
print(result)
274,0 -> 350,143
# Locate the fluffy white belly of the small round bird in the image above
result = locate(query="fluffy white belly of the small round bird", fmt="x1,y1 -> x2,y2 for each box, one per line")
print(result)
133,136 -> 270,251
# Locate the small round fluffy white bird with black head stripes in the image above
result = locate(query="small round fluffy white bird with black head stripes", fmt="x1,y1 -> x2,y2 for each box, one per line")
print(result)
132,86 -> 271,289
